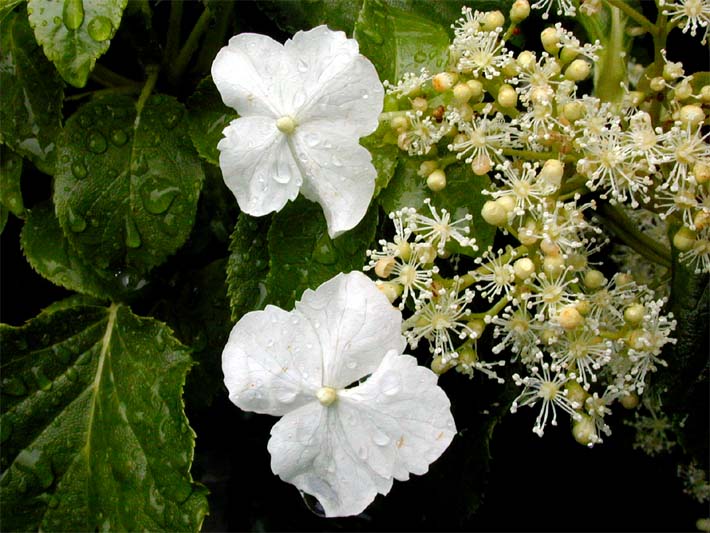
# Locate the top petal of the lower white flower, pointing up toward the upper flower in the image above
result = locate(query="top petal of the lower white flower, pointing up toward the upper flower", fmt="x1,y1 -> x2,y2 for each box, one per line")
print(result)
295,272 -> 406,389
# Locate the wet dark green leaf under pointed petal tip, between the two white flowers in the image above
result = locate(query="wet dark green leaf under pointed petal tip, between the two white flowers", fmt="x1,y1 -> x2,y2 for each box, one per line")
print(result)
265,198 -> 378,309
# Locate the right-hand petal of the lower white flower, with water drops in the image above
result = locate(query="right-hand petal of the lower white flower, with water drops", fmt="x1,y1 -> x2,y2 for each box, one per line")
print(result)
337,350 -> 456,481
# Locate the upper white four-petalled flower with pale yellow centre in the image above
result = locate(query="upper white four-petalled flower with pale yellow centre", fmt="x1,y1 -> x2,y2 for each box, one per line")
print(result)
212,26 -> 384,237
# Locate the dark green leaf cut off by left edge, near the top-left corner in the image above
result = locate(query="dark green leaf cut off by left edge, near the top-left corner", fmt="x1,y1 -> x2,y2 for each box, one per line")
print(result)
0,13 -> 64,174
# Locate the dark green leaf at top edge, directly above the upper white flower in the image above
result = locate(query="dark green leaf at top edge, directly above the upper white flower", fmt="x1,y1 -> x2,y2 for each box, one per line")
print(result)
259,0 -> 362,35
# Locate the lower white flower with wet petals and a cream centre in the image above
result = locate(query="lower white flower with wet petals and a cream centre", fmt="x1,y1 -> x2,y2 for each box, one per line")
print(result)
222,272 -> 456,517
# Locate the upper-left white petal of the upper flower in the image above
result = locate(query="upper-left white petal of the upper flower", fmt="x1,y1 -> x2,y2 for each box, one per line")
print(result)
212,33 -> 300,119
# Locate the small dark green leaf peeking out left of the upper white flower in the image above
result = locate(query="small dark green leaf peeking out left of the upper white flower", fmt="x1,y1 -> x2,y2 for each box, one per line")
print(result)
187,77 -> 238,166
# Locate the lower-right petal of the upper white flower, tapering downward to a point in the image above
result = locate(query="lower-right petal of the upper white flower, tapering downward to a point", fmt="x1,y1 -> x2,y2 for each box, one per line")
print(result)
292,122 -> 377,238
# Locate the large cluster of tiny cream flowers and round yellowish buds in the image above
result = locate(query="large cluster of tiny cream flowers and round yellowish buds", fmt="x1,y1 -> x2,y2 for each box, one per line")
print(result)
366,0 -> 710,445
